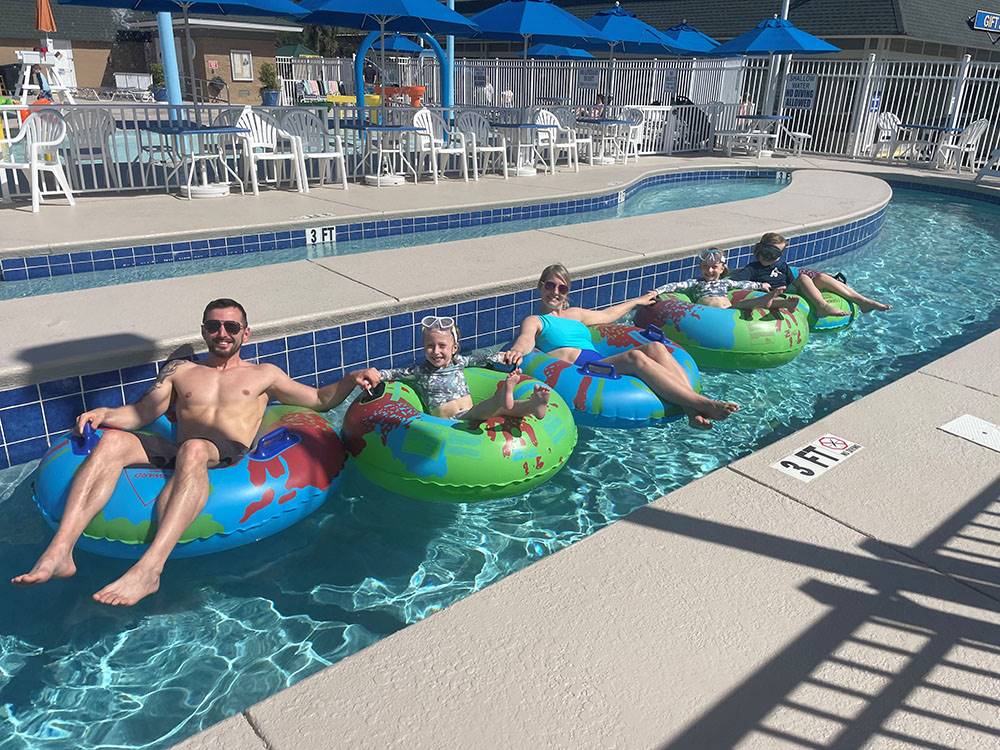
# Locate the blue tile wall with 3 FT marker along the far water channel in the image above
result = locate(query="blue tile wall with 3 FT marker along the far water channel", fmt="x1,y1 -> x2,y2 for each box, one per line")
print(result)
0,169 -> 777,281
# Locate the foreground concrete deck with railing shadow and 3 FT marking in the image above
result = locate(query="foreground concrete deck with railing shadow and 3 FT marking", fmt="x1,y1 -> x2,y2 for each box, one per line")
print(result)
180,332 -> 1000,750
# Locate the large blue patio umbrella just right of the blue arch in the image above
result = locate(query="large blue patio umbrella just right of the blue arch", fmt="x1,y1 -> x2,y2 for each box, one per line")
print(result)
470,0 -> 611,57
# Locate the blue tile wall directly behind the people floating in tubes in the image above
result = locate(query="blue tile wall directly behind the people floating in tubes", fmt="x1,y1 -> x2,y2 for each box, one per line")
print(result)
0,203 -> 885,469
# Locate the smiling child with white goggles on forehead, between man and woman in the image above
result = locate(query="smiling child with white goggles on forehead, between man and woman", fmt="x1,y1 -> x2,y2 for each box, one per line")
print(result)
358,315 -> 549,424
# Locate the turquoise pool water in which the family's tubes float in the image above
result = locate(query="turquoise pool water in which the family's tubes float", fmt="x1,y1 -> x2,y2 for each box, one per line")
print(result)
0,190 -> 1000,750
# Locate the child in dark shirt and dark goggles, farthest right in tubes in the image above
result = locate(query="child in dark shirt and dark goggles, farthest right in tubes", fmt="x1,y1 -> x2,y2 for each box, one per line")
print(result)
733,232 -> 892,317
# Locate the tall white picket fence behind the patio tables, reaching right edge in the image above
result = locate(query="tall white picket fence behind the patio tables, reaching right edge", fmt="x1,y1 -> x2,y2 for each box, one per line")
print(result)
279,55 -> 1000,165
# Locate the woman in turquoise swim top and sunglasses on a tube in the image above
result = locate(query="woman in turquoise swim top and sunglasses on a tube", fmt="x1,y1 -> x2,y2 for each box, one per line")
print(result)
501,263 -> 740,430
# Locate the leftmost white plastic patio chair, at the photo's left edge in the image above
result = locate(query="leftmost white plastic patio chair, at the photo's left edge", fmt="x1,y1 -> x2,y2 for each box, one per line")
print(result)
0,109 -> 76,213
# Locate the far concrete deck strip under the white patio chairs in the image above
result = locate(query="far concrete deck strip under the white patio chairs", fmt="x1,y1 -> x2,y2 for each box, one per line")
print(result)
0,154 -> 1000,257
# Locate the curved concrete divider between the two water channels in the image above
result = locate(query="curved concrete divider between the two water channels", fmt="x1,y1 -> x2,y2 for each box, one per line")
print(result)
0,169 -> 891,389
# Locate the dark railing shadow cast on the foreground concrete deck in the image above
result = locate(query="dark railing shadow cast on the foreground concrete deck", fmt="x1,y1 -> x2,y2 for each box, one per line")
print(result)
624,479 -> 1000,750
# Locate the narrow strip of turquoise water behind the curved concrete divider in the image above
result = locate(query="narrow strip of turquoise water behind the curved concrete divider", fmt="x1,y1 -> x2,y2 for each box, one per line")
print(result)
0,177 -> 787,300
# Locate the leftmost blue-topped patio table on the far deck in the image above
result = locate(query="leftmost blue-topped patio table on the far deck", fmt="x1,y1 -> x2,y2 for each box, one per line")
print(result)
115,120 -> 250,200
